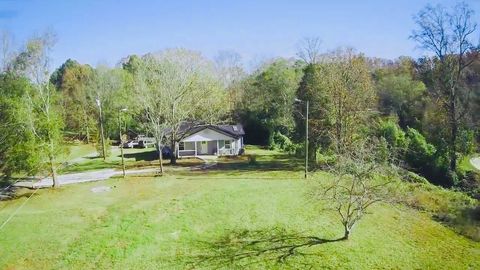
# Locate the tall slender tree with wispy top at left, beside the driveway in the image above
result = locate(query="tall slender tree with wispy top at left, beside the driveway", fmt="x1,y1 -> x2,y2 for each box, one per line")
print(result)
14,33 -> 64,187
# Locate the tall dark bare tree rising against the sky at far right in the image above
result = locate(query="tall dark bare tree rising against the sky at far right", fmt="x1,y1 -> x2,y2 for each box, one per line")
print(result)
411,3 -> 478,172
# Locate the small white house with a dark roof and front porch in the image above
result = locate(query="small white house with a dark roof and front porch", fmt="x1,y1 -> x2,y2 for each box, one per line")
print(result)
176,124 -> 245,158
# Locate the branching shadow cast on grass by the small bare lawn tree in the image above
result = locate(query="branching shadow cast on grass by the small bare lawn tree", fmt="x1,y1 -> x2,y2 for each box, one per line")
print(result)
189,228 -> 345,268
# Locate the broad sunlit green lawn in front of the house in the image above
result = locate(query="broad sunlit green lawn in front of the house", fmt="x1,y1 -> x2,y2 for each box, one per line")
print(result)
0,148 -> 480,269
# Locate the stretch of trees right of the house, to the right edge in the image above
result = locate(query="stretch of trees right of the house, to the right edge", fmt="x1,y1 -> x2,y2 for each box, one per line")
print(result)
235,3 -> 480,195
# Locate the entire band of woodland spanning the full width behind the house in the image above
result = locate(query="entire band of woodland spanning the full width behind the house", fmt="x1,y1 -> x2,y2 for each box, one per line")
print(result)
0,4 -> 480,198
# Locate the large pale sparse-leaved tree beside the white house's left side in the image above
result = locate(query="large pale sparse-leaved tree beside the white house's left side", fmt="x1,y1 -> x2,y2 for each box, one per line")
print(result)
133,49 -> 226,164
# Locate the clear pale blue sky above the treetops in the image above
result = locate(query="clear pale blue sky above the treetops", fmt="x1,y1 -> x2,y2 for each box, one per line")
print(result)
0,0 -> 480,69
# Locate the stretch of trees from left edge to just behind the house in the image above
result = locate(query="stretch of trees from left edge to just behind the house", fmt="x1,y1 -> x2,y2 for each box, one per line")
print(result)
0,36 -> 230,186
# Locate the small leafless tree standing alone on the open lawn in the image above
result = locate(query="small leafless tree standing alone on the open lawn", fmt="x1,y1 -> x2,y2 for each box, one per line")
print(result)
317,141 -> 397,239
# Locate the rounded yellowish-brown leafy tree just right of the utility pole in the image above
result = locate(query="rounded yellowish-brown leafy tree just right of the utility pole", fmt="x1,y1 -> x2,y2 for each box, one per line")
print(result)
297,50 -> 376,156
